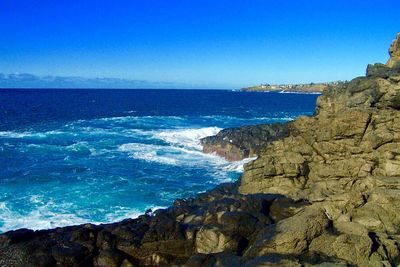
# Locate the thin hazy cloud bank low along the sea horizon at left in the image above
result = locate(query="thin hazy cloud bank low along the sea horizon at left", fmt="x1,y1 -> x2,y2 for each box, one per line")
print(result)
0,73 -> 184,89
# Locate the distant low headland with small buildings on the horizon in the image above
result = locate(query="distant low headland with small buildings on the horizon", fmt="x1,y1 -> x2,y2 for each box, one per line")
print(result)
241,81 -> 346,93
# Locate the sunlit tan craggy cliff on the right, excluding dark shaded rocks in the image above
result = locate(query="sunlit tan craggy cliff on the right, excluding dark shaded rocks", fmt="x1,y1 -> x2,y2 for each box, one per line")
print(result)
239,34 -> 400,266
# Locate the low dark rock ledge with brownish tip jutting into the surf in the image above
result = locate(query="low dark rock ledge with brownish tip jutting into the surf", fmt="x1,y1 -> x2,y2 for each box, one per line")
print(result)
201,123 -> 290,161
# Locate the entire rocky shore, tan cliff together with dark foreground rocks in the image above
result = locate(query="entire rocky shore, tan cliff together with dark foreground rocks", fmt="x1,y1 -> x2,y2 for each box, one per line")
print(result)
0,36 -> 400,266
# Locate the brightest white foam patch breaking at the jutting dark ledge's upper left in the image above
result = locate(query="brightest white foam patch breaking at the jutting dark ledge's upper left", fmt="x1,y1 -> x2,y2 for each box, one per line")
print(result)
154,127 -> 222,150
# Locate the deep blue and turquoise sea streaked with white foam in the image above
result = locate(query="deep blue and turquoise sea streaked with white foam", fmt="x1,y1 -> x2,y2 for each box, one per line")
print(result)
0,89 -> 317,232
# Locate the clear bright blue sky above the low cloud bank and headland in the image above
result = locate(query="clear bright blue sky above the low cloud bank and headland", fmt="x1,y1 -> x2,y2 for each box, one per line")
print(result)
0,0 -> 400,88
